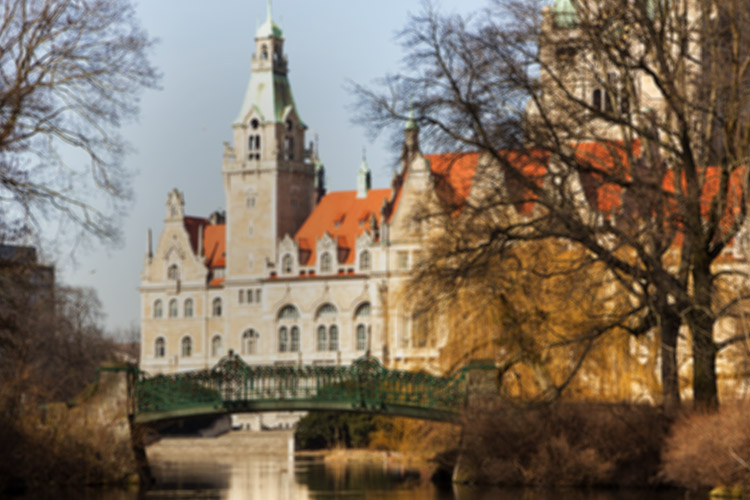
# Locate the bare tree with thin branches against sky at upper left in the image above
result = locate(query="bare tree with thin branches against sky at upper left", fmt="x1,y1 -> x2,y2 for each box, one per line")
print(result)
0,0 -> 158,243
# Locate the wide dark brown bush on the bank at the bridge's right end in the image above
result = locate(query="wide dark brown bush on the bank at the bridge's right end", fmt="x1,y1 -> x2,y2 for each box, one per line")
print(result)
457,403 -> 667,486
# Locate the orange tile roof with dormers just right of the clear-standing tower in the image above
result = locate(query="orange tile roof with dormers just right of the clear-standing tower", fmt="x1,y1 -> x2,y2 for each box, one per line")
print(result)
294,189 -> 391,266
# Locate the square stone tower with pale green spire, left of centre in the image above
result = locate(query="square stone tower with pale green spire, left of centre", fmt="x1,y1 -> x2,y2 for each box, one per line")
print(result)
223,2 -> 317,279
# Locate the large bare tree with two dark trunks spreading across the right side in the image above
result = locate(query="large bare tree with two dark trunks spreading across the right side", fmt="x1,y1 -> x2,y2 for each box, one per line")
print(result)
357,0 -> 750,408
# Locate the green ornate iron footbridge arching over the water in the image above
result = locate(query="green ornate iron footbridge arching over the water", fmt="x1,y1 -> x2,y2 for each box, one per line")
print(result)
134,353 -> 495,424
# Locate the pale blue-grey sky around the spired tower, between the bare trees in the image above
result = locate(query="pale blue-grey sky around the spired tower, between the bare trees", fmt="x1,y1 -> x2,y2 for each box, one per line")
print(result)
56,0 -> 486,332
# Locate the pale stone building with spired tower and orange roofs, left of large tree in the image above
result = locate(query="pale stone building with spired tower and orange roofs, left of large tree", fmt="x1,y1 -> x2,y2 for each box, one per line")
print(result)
140,9 -> 462,374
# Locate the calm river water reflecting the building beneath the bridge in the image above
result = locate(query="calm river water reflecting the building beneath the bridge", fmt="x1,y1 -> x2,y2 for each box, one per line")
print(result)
11,433 -> 685,500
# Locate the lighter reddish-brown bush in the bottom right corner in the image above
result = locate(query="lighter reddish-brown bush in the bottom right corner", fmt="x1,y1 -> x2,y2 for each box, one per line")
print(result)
662,402 -> 750,489
